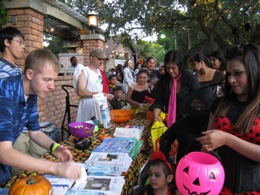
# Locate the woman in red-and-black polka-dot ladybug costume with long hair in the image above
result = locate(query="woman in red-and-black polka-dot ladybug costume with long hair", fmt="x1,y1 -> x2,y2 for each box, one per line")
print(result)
197,44 -> 260,195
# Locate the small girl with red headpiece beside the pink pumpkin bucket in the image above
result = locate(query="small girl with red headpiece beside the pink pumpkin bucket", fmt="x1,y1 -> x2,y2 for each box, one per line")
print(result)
139,151 -> 176,195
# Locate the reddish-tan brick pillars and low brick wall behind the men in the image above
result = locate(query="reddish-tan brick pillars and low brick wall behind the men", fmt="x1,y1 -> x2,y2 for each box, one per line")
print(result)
3,8 -> 104,140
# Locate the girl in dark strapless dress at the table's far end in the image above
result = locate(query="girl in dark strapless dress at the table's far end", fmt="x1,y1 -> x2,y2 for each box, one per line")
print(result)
126,69 -> 151,108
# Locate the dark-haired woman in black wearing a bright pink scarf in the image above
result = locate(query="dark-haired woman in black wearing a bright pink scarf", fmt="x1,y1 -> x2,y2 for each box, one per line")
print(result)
152,50 -> 200,127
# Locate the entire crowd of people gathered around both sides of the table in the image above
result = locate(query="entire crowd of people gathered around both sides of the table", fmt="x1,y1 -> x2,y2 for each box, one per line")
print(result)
0,27 -> 260,195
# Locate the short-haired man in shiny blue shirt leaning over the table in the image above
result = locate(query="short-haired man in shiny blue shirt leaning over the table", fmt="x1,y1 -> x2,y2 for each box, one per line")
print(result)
0,49 -> 81,185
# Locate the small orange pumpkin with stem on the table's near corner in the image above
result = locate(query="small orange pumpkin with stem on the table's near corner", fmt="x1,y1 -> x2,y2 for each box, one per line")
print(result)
8,175 -> 52,195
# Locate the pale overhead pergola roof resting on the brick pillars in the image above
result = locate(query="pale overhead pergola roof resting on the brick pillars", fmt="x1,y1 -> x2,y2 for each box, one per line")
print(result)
5,0 -> 104,39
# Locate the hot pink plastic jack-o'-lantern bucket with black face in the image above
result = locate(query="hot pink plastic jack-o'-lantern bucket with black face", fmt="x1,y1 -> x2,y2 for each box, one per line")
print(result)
176,152 -> 225,195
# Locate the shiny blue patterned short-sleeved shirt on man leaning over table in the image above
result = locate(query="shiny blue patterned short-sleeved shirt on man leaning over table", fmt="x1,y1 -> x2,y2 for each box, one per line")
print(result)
0,60 -> 40,175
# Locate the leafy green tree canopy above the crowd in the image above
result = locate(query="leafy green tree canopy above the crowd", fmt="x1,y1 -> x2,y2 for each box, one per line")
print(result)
61,0 -> 260,51
